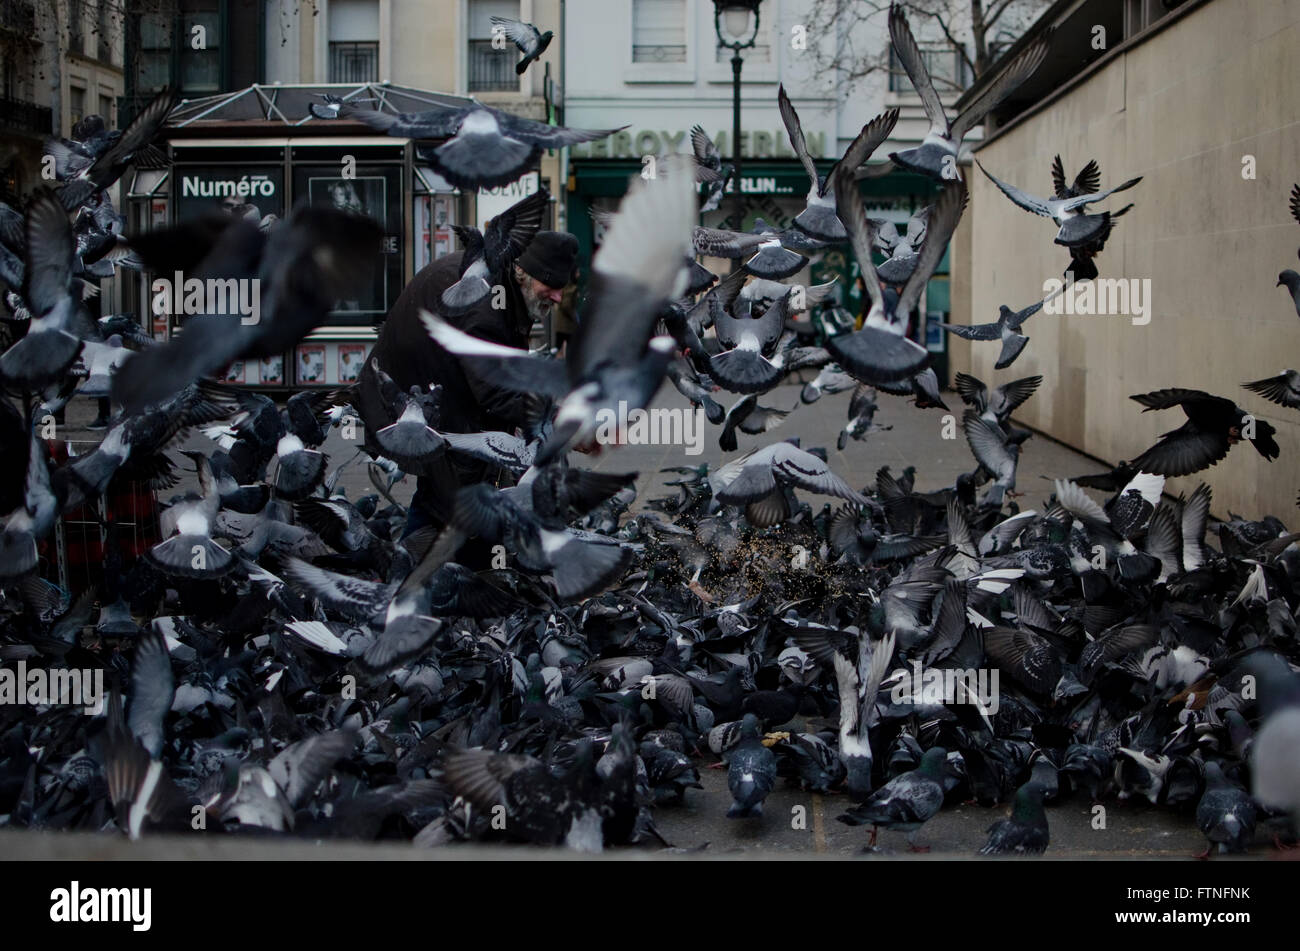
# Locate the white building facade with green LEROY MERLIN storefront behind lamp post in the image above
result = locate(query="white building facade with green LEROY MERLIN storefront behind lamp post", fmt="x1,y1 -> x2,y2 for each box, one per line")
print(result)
562,0 -> 1013,364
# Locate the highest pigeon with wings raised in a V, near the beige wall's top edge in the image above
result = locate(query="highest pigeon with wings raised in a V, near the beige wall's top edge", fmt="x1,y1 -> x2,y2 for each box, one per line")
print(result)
889,4 -> 1053,182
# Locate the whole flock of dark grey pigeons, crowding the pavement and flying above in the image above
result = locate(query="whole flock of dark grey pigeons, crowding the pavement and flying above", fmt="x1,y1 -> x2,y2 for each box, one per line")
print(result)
0,6 -> 1300,854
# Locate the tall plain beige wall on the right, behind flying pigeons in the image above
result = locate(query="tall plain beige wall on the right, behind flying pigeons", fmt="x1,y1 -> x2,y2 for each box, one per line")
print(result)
953,0 -> 1300,522
